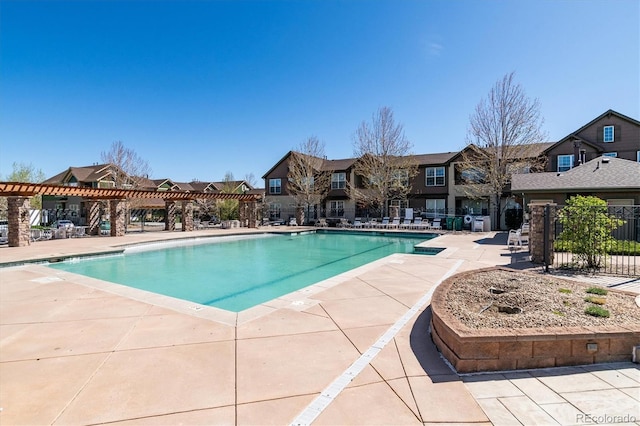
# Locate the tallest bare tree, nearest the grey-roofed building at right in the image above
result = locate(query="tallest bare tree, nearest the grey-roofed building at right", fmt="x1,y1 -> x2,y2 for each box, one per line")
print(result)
457,72 -> 546,229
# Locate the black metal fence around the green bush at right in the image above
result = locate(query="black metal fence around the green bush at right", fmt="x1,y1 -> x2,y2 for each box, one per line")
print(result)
545,206 -> 640,276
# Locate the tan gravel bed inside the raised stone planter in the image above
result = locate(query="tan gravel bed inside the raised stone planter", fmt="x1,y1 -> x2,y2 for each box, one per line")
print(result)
445,270 -> 640,329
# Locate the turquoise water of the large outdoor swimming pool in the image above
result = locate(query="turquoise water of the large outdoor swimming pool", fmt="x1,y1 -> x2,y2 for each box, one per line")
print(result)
49,232 -> 435,312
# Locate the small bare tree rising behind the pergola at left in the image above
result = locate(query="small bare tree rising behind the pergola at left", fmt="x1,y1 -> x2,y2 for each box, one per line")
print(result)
100,141 -> 151,188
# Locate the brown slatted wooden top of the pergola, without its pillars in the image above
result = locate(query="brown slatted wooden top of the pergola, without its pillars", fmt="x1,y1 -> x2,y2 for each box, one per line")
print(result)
0,182 -> 261,201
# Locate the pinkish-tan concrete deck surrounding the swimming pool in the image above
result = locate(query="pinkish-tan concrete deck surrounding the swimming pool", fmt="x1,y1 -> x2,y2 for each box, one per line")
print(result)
0,227 -> 640,425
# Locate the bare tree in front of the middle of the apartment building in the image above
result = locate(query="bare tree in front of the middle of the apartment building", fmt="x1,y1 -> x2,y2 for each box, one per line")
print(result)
347,107 -> 418,215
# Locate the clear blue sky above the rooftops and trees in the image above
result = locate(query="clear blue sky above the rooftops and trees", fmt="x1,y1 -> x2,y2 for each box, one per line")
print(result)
0,0 -> 640,186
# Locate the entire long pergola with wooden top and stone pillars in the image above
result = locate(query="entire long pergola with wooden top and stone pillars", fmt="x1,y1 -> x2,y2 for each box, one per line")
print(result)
0,182 -> 261,247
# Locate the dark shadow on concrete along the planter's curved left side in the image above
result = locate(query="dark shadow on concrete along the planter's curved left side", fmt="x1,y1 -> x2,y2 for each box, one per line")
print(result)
409,306 -> 460,383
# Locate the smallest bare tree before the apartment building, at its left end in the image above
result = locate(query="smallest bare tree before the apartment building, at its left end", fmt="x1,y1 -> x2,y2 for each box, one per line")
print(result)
287,136 -> 332,224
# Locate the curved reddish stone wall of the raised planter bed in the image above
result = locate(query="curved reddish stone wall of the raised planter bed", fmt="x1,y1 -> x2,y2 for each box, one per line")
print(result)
431,268 -> 640,373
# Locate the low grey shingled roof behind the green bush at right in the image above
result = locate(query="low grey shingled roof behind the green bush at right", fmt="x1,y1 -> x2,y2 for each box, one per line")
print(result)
511,157 -> 640,192
